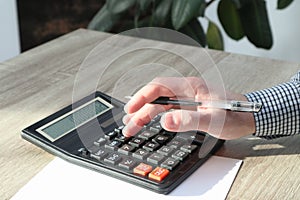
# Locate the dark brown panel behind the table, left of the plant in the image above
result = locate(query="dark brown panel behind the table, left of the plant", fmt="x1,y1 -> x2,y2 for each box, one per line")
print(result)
17,0 -> 105,52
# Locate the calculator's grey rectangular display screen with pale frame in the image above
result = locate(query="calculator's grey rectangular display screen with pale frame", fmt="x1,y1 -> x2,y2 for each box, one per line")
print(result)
36,97 -> 113,142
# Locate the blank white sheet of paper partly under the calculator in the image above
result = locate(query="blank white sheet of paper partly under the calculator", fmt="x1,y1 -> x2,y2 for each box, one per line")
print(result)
12,156 -> 242,200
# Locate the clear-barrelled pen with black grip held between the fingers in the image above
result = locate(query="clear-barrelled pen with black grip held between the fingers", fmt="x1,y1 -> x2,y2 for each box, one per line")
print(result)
125,96 -> 262,112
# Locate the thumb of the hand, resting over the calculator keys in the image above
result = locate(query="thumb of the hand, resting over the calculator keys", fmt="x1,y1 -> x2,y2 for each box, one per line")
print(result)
160,110 -> 210,132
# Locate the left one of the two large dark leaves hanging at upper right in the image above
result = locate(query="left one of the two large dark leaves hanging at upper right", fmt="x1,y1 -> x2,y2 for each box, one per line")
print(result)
218,0 -> 245,40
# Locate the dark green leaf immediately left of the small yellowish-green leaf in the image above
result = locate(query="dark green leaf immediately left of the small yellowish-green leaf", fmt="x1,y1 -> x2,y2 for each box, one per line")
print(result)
179,18 -> 206,47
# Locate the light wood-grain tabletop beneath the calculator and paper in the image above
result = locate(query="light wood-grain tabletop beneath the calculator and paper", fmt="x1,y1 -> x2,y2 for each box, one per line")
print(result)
0,29 -> 300,199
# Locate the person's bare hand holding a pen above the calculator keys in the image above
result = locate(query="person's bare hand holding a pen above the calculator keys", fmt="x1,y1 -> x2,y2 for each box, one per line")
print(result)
123,77 -> 255,140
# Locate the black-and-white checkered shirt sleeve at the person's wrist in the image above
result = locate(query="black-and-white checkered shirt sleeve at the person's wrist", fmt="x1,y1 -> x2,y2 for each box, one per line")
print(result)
245,71 -> 300,139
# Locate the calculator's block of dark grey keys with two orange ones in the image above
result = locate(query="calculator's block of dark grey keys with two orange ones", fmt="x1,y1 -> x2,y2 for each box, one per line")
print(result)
85,116 -> 204,182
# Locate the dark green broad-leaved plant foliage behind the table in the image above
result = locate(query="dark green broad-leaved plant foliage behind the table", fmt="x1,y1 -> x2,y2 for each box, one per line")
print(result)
88,0 -> 293,50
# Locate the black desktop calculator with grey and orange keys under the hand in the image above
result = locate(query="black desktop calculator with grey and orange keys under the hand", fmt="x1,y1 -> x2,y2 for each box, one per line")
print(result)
22,91 -> 224,194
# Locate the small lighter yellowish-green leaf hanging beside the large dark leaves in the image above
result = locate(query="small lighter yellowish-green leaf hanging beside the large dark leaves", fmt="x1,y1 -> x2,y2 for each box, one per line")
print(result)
206,21 -> 224,50
